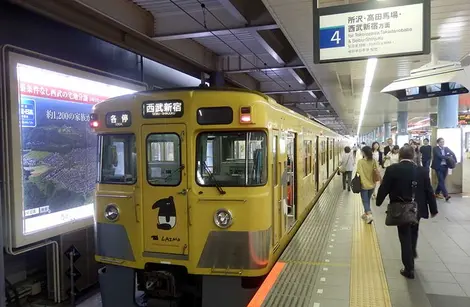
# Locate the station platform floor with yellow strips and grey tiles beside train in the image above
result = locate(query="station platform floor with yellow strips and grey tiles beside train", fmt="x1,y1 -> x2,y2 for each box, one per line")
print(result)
249,176 -> 470,307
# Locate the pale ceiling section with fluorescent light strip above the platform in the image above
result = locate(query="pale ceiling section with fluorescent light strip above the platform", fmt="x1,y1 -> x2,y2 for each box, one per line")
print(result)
263,0 -> 470,133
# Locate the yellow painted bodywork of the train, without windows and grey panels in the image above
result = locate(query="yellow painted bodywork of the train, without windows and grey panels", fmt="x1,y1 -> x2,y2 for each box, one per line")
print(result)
94,90 -> 343,276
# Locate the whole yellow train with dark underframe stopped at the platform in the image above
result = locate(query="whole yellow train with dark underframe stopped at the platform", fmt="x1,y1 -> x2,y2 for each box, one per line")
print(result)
90,88 -> 345,307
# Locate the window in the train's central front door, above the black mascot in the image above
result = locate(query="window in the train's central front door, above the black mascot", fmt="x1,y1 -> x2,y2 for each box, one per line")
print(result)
147,133 -> 183,186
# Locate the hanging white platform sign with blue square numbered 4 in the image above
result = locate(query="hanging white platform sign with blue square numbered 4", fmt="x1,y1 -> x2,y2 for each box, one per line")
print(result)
313,0 -> 431,64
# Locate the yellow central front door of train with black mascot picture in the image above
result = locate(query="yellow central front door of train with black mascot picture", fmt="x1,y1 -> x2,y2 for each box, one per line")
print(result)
141,124 -> 188,258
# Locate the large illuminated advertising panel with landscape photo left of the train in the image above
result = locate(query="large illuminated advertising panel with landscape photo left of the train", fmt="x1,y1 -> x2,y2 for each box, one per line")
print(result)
3,47 -> 145,245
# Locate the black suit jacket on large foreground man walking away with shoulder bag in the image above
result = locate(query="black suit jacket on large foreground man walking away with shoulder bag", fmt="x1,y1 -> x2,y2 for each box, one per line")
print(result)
377,161 -> 438,219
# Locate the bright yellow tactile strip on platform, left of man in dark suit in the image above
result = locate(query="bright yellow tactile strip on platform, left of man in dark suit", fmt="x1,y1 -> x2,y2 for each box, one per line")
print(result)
349,195 -> 392,307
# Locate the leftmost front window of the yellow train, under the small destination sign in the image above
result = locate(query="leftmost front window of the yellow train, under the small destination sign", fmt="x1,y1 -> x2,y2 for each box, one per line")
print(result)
98,134 -> 137,184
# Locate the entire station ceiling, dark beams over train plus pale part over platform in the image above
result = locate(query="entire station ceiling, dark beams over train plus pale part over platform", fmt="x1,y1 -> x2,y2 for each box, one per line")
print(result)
10,0 -> 470,135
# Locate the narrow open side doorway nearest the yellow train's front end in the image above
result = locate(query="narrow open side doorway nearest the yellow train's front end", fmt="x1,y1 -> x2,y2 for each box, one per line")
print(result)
286,132 -> 297,229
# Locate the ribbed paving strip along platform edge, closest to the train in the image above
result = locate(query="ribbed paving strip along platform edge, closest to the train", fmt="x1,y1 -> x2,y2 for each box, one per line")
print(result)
262,178 -> 343,307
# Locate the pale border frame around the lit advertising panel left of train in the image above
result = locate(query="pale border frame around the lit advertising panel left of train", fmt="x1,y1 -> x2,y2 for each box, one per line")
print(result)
0,45 -> 148,248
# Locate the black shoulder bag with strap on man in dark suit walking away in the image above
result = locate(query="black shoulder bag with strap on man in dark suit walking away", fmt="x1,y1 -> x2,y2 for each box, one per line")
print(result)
385,167 -> 418,226
